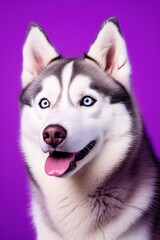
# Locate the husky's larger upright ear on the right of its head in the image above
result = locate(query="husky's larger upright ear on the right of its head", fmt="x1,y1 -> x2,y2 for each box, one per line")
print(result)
87,18 -> 131,89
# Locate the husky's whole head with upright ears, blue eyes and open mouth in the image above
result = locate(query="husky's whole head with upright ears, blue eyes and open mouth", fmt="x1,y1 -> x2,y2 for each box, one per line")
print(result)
20,18 -> 133,177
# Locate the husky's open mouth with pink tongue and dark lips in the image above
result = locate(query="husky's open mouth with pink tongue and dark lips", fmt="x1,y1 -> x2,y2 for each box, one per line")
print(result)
45,140 -> 96,177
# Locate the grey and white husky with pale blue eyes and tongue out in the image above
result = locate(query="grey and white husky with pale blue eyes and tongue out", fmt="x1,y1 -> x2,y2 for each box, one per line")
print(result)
20,18 -> 160,240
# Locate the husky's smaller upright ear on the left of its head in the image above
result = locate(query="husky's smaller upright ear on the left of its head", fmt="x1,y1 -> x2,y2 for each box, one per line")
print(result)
22,23 -> 58,87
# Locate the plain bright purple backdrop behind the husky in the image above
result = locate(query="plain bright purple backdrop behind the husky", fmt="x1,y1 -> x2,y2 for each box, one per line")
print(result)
0,0 -> 160,240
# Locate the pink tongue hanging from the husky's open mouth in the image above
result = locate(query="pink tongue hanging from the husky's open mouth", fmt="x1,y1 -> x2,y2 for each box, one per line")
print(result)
45,153 -> 75,176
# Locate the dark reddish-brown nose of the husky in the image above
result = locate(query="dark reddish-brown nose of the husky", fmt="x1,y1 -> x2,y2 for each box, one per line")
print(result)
43,125 -> 67,148
